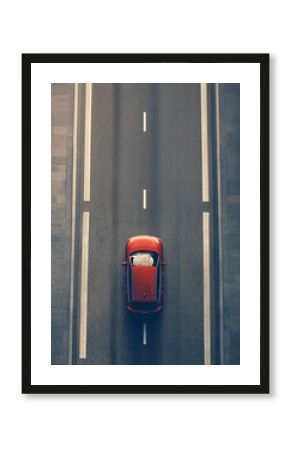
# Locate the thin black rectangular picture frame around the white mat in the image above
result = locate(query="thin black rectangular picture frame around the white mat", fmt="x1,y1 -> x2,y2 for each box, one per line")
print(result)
22,53 -> 269,394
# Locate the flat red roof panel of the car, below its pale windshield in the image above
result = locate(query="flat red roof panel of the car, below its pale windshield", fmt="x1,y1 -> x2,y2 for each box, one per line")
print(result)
132,266 -> 157,302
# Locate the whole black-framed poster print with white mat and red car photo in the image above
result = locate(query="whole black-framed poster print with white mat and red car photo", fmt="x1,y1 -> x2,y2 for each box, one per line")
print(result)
22,54 -> 269,394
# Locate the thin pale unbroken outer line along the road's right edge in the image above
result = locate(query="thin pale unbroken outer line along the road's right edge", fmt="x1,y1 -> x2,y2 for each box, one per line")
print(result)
215,83 -> 224,364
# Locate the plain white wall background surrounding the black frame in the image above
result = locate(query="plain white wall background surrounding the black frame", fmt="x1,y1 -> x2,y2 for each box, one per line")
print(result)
0,0 -> 284,450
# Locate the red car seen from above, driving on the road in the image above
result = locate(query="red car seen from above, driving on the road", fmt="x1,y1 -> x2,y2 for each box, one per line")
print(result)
123,236 -> 165,314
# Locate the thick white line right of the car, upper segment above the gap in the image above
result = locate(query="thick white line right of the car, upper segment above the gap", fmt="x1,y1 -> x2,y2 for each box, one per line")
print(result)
200,83 -> 209,202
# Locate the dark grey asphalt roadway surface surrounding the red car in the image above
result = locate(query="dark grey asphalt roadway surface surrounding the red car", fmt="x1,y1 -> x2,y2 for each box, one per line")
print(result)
73,84 -> 216,364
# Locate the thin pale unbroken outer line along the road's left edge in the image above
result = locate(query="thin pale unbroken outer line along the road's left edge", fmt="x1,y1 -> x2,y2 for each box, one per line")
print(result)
68,83 -> 79,364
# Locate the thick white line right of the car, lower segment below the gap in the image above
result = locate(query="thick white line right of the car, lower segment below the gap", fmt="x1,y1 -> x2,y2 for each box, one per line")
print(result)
202,212 -> 211,364
